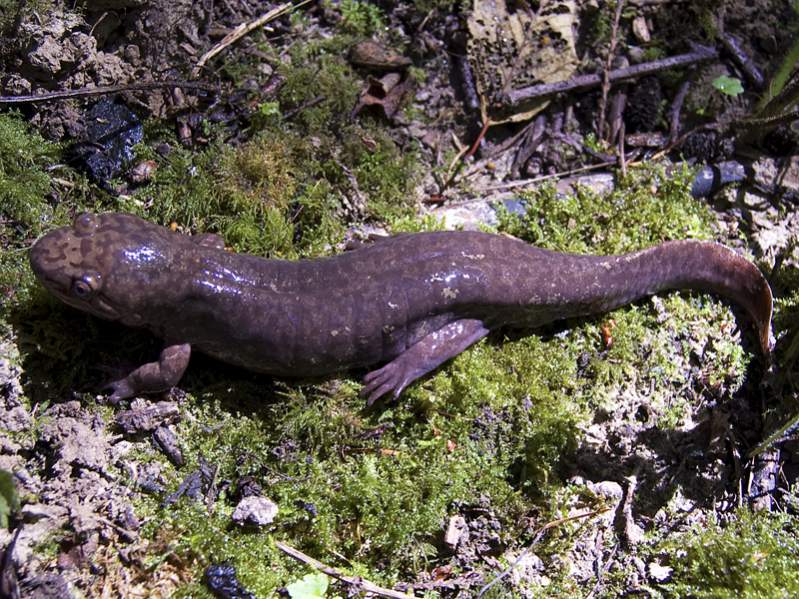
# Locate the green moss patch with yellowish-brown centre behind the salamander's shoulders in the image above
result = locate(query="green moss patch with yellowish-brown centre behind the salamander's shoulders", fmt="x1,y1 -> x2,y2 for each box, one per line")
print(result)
122,41 -> 418,258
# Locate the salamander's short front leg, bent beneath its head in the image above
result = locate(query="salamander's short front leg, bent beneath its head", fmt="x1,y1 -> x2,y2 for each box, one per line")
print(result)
106,343 -> 191,404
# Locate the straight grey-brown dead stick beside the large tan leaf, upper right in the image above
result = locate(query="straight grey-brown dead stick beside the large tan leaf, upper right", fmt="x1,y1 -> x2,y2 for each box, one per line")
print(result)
504,46 -> 719,106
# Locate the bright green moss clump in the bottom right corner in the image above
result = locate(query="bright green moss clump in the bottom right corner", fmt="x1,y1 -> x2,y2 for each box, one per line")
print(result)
658,510 -> 799,599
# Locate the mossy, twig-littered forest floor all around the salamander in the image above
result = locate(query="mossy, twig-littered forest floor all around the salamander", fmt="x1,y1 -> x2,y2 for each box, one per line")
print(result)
0,0 -> 799,597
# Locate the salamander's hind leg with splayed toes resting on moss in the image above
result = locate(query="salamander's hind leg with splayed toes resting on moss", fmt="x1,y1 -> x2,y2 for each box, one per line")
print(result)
361,319 -> 488,406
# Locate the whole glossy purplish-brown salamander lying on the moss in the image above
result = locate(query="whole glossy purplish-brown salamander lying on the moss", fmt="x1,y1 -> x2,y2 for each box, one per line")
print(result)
30,214 -> 772,403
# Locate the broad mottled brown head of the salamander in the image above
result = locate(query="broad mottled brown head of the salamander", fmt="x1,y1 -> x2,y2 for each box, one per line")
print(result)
30,213 -> 180,325
